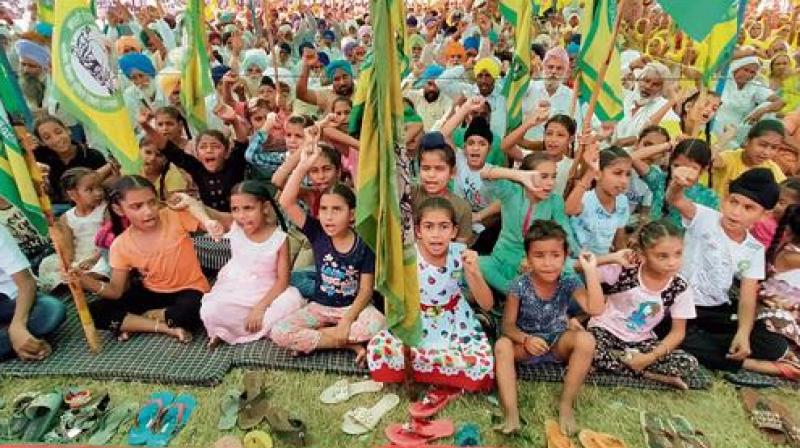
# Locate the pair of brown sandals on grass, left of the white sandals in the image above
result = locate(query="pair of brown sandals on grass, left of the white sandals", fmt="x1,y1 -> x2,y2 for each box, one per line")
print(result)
236,372 -> 308,446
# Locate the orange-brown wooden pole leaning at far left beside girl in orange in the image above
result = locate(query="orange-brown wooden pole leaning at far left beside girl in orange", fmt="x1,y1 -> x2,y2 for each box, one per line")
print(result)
14,124 -> 100,354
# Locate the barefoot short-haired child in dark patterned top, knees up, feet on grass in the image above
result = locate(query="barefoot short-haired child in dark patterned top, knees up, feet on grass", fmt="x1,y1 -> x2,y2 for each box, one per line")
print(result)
495,221 -> 603,435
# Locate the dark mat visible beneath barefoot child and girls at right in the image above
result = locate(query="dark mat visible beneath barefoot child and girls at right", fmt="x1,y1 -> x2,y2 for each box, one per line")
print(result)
517,363 -> 713,390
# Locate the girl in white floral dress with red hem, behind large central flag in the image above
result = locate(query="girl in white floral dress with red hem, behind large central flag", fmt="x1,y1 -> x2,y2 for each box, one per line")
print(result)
367,198 -> 494,392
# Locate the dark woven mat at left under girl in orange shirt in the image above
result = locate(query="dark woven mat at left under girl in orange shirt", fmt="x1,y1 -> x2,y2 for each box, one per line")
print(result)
0,304 -> 233,386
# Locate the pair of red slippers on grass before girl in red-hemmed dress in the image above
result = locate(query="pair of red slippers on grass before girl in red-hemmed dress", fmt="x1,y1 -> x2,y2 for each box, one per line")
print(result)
385,388 -> 461,446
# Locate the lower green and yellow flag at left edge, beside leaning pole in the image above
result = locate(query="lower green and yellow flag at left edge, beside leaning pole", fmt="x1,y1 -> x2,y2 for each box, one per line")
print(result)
0,102 -> 47,235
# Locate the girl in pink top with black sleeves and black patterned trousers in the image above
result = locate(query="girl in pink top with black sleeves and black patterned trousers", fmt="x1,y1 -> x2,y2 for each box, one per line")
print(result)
589,218 -> 698,389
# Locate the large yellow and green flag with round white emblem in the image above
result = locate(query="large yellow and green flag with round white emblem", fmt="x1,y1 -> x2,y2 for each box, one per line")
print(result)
51,0 -> 140,173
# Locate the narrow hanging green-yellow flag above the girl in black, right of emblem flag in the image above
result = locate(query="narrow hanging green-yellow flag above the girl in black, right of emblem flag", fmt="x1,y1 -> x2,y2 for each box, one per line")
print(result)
181,0 -> 214,130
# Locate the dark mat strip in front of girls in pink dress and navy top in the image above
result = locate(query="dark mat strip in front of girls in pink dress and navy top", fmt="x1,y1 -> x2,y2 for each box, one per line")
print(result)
232,340 -> 369,375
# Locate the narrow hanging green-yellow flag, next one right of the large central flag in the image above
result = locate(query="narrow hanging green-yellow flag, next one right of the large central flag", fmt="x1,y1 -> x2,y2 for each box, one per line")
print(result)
500,0 -> 534,131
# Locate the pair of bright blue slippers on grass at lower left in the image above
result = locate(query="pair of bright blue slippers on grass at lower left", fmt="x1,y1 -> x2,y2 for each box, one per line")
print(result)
128,391 -> 197,446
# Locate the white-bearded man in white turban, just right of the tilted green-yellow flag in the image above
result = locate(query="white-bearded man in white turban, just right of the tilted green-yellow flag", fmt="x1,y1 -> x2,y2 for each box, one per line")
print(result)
615,62 -> 680,141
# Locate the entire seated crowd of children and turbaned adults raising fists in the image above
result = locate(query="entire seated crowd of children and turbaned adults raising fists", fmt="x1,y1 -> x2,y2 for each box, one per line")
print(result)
0,0 -> 800,433
